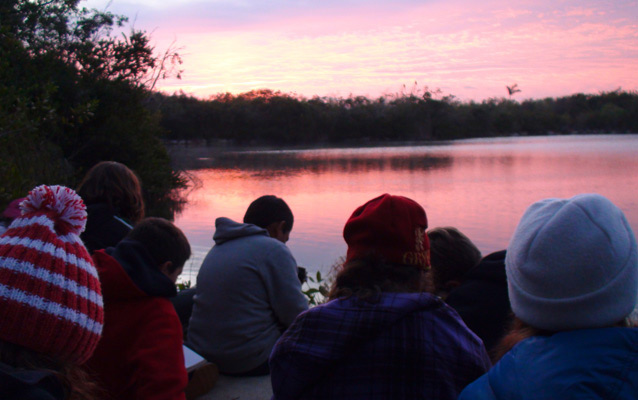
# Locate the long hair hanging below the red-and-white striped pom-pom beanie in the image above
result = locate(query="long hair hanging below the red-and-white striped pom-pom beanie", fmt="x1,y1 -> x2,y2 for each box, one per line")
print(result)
0,340 -> 102,400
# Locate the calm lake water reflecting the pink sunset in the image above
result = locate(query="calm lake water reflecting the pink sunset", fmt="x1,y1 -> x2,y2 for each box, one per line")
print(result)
175,135 -> 638,282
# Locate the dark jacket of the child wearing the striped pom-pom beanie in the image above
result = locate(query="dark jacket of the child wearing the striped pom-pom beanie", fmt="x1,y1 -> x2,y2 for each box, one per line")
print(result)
0,363 -> 66,400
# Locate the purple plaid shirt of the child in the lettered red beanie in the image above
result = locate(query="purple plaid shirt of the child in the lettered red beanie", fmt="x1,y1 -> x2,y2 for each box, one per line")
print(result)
270,293 -> 491,400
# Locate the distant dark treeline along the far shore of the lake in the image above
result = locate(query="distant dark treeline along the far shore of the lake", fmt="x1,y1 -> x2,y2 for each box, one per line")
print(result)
153,87 -> 638,146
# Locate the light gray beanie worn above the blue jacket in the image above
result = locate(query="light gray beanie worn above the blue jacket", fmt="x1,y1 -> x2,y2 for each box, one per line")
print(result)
505,194 -> 638,331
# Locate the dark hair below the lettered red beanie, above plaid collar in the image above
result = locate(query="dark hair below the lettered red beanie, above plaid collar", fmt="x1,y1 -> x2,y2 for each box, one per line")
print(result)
328,258 -> 432,300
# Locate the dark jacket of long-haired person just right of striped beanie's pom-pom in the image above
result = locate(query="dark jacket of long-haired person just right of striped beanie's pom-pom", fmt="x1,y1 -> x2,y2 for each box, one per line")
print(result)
80,203 -> 133,253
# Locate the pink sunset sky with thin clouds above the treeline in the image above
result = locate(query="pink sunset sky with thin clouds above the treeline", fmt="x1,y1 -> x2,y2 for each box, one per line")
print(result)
82,0 -> 638,101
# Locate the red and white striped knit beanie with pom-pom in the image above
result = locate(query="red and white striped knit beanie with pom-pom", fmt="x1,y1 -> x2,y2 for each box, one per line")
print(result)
0,185 -> 104,364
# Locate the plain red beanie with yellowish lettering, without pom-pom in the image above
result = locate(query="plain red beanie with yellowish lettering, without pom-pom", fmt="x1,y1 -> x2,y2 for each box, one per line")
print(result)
343,194 -> 430,269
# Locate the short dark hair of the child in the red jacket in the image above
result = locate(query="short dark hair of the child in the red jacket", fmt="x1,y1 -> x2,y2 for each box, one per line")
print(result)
126,217 -> 191,272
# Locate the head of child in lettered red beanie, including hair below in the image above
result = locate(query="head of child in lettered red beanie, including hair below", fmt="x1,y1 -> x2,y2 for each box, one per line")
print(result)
330,194 -> 430,298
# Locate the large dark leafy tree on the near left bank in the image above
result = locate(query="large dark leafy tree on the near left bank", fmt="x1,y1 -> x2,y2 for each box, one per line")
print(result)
0,0 -> 184,216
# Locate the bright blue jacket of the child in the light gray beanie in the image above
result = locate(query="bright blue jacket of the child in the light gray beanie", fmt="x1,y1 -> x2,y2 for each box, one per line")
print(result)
459,328 -> 638,400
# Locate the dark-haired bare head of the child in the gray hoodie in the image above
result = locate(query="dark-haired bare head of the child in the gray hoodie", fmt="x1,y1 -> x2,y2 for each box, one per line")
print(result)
244,195 -> 294,243
